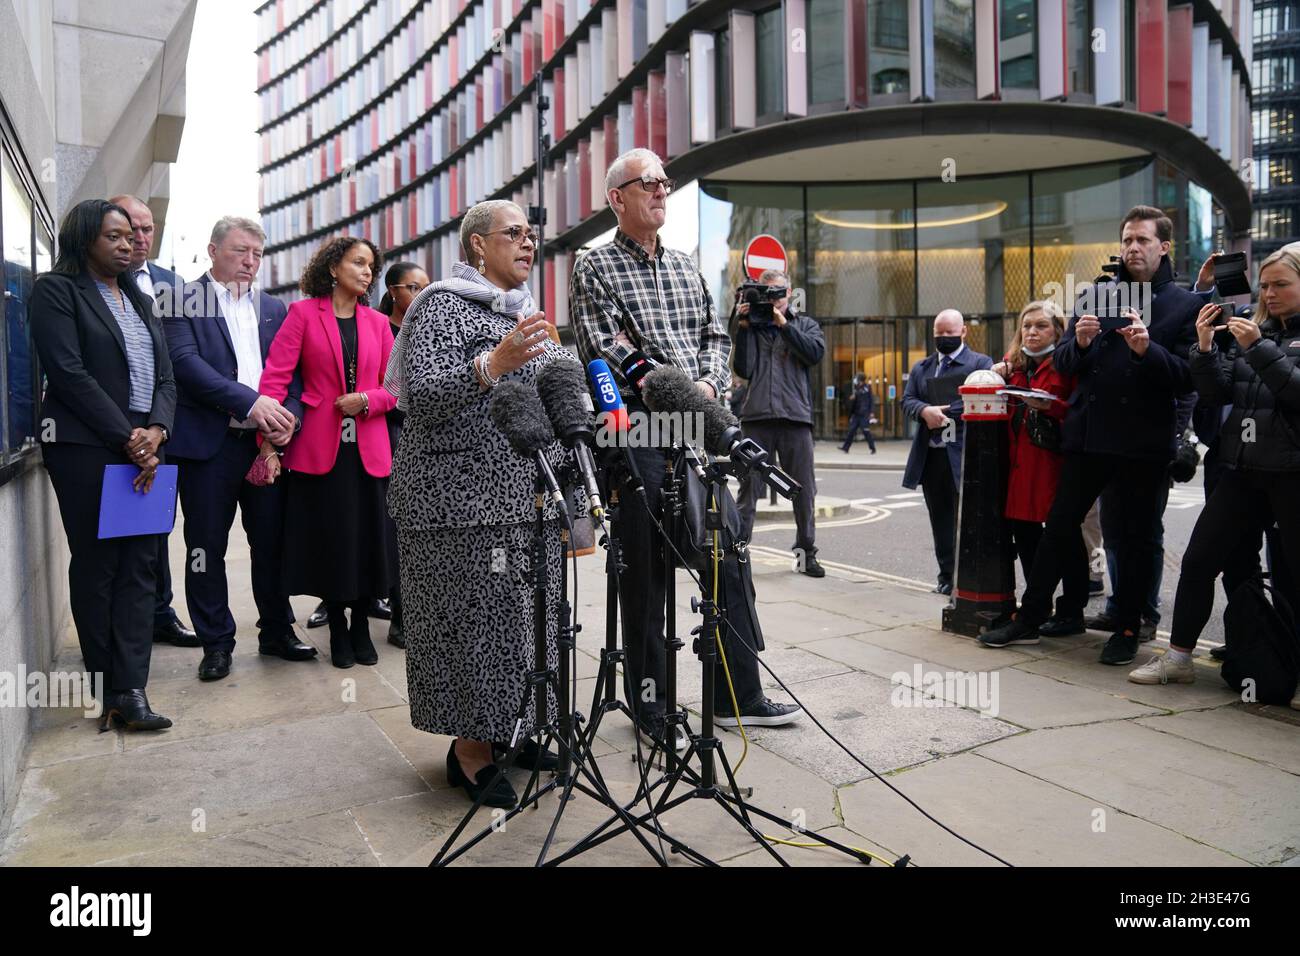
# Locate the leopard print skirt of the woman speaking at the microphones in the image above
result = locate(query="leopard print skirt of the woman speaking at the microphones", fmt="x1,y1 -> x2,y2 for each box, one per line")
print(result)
398,522 -> 563,743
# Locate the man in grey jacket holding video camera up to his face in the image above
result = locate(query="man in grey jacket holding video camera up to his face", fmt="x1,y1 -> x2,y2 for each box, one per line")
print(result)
732,269 -> 826,578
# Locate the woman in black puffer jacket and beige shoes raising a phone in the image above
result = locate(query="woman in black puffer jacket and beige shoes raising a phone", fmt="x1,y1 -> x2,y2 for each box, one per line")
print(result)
1128,242 -> 1300,709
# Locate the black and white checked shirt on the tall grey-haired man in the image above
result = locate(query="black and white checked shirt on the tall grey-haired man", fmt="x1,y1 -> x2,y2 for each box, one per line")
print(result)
569,229 -> 731,397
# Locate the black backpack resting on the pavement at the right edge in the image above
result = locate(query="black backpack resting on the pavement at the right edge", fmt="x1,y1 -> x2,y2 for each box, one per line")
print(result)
1219,575 -> 1300,704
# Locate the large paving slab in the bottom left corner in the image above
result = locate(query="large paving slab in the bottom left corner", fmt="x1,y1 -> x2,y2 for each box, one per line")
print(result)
0,714 -> 428,866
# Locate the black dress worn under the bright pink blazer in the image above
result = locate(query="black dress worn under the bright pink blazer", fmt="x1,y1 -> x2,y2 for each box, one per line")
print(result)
285,316 -> 397,604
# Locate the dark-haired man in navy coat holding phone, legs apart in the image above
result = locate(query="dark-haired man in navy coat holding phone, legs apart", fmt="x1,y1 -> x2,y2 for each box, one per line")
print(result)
980,206 -> 1203,665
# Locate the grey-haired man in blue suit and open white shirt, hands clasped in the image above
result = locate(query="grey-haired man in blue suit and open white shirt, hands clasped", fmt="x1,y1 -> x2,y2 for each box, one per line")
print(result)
164,216 -> 316,680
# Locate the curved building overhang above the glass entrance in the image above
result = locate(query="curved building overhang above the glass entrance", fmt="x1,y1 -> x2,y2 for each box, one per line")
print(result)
551,101 -> 1251,248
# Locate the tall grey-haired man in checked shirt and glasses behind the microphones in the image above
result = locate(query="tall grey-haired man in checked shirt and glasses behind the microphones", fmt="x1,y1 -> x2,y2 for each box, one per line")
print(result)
569,150 -> 801,750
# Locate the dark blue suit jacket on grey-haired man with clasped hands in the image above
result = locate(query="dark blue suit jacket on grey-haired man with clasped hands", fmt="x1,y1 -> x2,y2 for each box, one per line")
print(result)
163,273 -> 303,462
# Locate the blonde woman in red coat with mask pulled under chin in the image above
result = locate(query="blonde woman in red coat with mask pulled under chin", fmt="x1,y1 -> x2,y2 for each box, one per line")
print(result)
993,299 -> 1088,634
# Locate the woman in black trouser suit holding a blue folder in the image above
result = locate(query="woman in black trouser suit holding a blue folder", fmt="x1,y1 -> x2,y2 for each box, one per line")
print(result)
30,199 -> 176,730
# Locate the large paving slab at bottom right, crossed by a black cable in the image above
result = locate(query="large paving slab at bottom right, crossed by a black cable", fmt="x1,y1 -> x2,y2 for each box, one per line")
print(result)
840,749 -> 1244,866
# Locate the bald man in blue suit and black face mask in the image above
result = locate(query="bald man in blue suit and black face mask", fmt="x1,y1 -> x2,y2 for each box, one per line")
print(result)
902,308 -> 993,594
